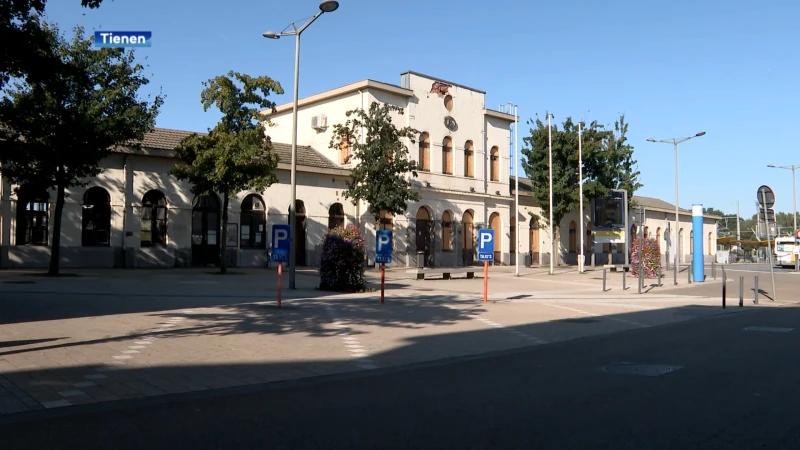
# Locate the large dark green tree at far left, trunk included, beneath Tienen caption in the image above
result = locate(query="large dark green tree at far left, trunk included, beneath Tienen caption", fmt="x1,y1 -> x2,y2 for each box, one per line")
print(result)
0,23 -> 163,275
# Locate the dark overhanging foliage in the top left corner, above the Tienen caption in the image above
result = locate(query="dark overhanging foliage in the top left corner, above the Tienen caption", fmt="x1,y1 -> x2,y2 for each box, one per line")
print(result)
0,0 -> 103,89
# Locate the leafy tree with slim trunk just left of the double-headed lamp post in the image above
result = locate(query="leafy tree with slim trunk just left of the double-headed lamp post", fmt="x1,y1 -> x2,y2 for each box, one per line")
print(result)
171,71 -> 283,273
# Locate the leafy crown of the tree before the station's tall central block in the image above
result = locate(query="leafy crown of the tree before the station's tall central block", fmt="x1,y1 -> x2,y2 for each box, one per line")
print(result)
330,102 -> 420,222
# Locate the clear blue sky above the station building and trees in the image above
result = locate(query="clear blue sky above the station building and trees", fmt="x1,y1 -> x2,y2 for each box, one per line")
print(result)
42,0 -> 800,220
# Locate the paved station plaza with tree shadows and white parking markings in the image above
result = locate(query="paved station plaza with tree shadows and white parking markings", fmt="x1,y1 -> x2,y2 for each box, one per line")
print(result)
0,267 -> 800,420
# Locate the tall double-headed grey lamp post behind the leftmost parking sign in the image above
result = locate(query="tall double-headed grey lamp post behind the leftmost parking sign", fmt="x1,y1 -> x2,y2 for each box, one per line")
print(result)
262,0 -> 339,289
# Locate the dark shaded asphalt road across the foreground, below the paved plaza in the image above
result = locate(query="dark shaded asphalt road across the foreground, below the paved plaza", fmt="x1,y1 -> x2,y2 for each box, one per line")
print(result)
0,308 -> 800,450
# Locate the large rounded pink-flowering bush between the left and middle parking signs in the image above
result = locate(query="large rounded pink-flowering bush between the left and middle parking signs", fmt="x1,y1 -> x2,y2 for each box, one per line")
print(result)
319,225 -> 367,291
